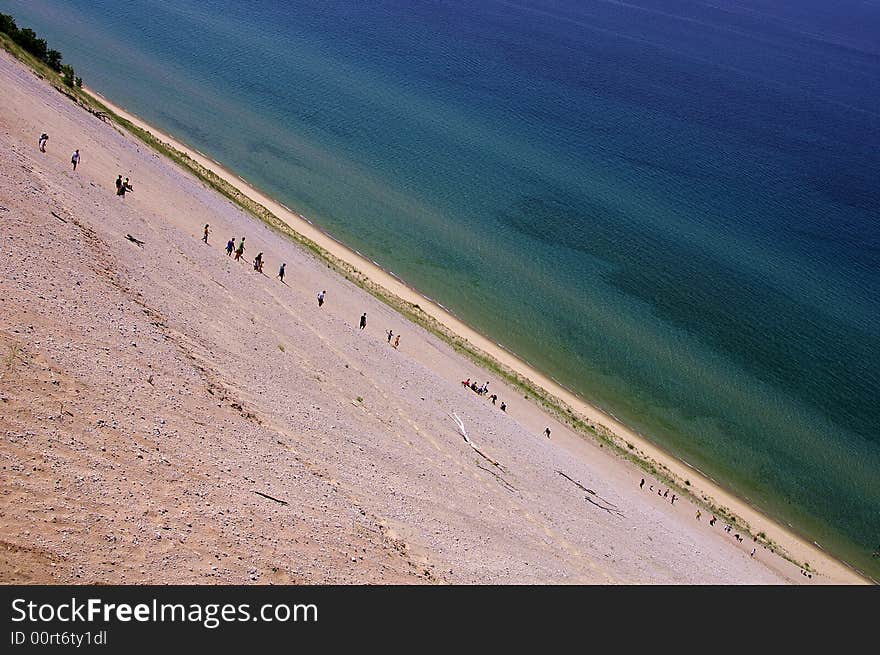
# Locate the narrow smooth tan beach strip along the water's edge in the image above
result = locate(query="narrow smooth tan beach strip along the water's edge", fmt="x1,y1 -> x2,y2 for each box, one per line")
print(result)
82,87 -> 873,584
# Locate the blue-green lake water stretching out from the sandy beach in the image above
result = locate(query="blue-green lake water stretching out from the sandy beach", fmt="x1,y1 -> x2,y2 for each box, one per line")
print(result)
0,0 -> 880,577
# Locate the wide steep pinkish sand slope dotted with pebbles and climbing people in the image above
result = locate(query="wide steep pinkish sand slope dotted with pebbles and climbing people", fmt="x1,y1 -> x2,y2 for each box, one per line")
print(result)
0,53 -> 848,584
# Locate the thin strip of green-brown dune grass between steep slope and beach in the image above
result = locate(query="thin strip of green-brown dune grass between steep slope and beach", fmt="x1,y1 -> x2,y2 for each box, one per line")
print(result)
0,33 -> 815,572
